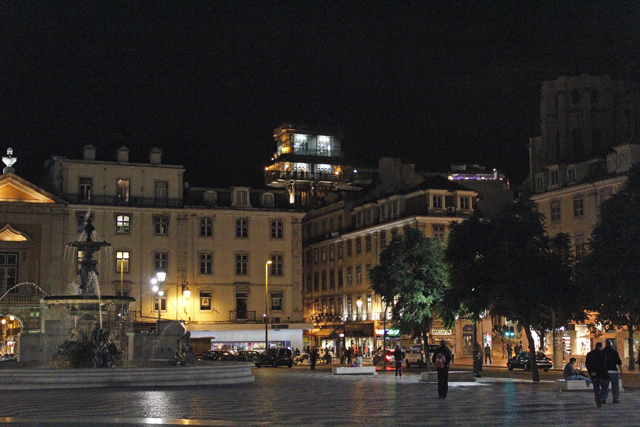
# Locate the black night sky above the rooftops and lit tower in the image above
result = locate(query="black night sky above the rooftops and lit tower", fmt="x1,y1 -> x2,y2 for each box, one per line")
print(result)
0,0 -> 640,186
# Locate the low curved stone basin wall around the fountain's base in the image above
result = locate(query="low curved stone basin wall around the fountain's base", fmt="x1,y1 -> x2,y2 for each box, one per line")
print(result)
0,362 -> 255,390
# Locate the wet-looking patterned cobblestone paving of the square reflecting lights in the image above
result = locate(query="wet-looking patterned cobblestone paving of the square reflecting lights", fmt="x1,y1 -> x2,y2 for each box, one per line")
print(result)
0,368 -> 640,427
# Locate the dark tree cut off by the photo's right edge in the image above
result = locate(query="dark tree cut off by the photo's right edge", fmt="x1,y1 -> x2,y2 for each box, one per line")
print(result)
577,164 -> 640,370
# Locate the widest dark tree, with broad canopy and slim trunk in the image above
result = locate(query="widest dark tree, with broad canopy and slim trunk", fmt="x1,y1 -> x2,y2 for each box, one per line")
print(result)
439,200 -> 584,381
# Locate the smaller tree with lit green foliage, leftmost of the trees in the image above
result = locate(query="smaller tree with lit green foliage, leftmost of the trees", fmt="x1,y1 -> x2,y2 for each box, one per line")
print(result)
371,228 -> 447,366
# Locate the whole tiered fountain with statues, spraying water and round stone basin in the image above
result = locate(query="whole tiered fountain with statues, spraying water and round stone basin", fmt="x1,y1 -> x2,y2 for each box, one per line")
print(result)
0,214 -> 255,389
